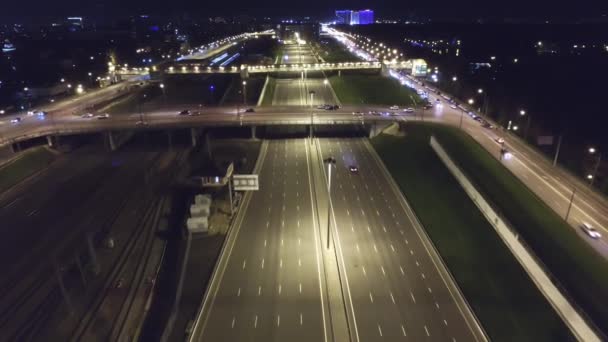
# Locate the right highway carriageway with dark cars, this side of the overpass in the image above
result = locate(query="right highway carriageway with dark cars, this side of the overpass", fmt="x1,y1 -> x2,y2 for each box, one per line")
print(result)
319,139 -> 476,341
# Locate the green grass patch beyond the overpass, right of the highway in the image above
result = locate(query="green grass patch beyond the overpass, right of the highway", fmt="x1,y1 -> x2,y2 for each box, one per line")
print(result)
329,72 -> 422,107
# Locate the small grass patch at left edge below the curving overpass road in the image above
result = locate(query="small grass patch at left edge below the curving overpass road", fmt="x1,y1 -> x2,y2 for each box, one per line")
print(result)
0,147 -> 55,193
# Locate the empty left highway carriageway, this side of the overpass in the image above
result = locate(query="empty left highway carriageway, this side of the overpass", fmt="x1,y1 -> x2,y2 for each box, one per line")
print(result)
194,139 -> 326,341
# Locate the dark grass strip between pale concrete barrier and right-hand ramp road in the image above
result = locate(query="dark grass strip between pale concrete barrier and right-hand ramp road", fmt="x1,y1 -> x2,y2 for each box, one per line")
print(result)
434,121 -> 608,334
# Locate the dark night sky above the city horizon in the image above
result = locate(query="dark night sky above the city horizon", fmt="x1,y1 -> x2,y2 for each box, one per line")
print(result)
0,0 -> 608,22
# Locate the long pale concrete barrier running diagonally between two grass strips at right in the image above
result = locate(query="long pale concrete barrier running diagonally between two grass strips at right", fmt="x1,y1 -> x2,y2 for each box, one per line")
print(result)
430,137 -> 600,342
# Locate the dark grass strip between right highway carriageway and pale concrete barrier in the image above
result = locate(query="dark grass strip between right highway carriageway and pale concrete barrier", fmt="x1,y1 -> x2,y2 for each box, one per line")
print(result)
372,124 -> 574,341
